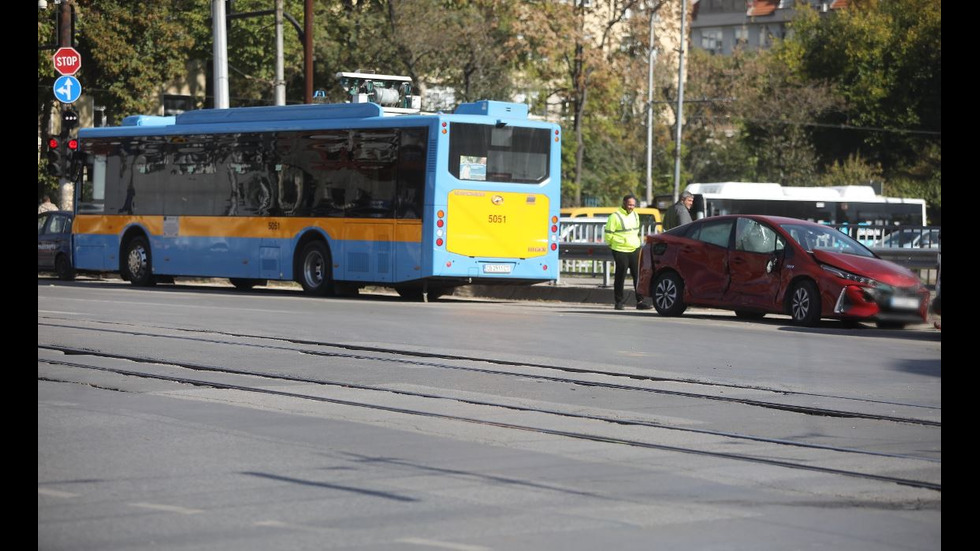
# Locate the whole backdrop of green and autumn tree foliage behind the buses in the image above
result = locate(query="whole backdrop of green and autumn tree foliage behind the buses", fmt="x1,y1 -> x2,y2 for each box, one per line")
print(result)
38,0 -> 942,214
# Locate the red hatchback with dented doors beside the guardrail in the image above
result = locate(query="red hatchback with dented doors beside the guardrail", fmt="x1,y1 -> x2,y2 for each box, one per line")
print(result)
638,215 -> 929,328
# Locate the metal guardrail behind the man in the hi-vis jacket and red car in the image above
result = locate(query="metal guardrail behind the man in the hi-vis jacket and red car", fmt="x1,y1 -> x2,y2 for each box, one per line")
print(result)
558,219 -> 941,286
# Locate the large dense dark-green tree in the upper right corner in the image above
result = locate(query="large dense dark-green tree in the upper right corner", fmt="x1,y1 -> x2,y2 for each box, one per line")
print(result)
789,0 -> 942,196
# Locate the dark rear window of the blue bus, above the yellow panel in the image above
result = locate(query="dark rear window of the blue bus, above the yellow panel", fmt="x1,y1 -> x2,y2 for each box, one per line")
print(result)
449,123 -> 551,184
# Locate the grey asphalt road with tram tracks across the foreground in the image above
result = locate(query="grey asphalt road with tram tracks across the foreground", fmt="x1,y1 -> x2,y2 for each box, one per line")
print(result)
38,278 -> 942,550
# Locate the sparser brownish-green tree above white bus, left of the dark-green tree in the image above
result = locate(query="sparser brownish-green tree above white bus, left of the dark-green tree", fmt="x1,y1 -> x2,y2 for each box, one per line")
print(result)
685,44 -> 840,186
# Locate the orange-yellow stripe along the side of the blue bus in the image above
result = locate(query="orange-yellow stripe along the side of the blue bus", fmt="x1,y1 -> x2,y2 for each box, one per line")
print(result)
74,215 -> 422,243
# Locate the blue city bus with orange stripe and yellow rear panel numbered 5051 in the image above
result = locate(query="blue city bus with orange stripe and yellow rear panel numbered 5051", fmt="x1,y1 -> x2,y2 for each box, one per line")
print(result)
74,101 -> 561,296
